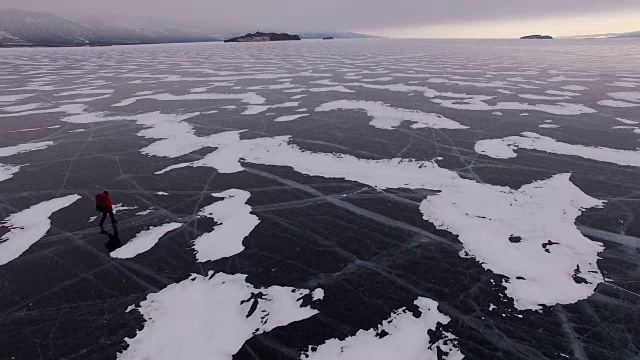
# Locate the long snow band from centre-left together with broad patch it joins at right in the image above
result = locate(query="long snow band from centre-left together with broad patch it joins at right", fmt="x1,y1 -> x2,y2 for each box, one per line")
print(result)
150,128 -> 602,309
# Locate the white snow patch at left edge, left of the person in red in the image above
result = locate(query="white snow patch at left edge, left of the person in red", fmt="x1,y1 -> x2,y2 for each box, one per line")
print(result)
0,195 -> 80,265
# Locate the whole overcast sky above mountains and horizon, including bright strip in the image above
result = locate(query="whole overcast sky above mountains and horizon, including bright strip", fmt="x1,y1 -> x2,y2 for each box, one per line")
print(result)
0,0 -> 640,37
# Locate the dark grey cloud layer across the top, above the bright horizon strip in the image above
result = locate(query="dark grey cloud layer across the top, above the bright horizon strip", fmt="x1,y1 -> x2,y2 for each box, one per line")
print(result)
2,0 -> 640,31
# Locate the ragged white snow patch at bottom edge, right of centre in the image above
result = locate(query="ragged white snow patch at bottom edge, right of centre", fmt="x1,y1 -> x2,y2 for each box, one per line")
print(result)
301,298 -> 464,360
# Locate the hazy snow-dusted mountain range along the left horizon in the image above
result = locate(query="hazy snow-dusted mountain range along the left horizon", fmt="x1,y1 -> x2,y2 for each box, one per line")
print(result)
0,9 -> 376,47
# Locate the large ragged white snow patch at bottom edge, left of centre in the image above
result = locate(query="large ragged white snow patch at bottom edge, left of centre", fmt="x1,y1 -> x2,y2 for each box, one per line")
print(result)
118,273 -> 317,360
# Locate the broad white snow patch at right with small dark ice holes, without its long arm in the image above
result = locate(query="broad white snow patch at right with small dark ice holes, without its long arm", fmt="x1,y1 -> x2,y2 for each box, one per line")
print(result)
420,174 -> 604,310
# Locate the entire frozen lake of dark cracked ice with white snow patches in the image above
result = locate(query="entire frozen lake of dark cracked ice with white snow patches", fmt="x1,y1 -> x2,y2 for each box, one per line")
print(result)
0,39 -> 640,360
